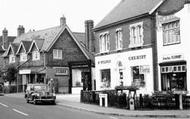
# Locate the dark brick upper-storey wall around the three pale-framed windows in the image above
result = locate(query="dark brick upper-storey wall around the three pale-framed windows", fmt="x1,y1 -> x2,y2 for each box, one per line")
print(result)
95,17 -> 153,53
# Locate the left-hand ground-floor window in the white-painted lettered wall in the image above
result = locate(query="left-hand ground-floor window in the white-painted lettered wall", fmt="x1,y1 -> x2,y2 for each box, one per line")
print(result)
101,69 -> 111,88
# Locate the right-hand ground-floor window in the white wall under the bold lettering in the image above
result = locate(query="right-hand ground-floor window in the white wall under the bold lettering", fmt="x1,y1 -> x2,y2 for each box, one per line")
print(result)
132,66 -> 145,87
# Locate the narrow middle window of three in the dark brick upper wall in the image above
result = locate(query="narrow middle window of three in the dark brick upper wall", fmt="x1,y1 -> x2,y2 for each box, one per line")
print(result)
116,29 -> 123,50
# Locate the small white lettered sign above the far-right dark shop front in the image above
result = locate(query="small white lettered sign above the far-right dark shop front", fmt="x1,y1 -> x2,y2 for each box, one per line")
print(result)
162,54 -> 184,61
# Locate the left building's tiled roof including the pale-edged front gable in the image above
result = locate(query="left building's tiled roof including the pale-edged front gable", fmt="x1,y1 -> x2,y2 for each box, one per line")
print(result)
13,24 -> 91,59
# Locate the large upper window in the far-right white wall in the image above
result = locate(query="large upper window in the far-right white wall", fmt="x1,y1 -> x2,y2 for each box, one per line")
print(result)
162,20 -> 180,45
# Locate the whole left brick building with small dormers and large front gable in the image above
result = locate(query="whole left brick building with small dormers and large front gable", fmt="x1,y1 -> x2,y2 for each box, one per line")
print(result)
4,16 -> 94,93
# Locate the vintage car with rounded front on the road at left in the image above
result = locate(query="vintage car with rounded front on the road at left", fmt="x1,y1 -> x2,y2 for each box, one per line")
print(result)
25,84 -> 56,104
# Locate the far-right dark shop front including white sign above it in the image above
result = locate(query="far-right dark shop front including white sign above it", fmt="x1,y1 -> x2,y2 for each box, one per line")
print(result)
159,54 -> 187,93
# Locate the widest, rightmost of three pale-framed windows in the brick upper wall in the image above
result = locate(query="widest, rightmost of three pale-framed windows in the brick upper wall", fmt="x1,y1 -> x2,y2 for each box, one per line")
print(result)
129,22 -> 144,48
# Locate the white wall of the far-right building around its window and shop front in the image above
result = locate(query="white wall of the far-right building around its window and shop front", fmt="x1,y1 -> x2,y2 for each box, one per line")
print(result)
157,4 -> 190,91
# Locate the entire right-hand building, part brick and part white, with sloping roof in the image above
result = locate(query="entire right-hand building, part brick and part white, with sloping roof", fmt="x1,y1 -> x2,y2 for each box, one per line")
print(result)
94,0 -> 190,94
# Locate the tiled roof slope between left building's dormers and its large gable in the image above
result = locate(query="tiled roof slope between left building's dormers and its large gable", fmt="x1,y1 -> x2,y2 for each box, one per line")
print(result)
13,26 -> 64,51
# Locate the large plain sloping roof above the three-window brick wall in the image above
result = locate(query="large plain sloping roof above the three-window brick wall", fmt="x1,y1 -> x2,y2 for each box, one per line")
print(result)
95,0 -> 162,28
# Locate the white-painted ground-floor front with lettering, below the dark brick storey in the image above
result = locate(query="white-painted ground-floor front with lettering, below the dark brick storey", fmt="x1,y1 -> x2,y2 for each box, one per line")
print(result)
95,48 -> 154,94
